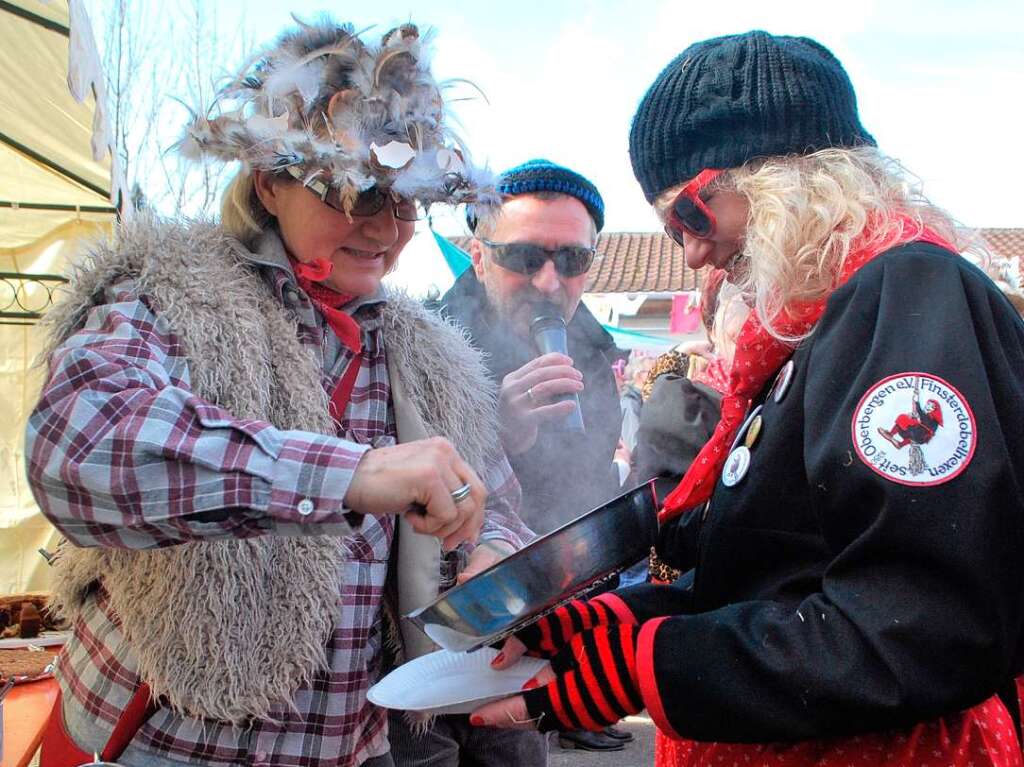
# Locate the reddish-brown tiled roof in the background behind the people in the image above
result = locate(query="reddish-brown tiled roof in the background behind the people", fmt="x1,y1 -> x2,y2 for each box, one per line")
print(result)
452,228 -> 1024,293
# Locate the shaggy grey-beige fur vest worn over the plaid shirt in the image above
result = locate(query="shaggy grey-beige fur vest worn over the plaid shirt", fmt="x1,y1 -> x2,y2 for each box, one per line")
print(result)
41,219 -> 499,723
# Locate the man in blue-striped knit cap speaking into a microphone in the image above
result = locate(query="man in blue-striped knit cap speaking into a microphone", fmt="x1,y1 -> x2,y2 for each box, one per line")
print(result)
442,160 -> 631,751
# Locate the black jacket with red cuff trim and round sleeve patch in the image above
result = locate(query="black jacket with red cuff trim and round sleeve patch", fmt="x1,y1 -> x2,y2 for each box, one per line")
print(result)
618,244 -> 1024,742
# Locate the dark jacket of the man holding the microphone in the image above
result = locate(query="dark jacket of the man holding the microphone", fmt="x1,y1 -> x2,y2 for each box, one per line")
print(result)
441,269 -> 622,534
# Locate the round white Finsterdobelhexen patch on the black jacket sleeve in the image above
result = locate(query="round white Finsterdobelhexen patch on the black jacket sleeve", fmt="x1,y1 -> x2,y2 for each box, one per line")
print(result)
853,373 -> 978,486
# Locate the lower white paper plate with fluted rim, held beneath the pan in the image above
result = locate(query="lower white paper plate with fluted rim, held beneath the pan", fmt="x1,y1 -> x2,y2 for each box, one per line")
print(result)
367,647 -> 548,714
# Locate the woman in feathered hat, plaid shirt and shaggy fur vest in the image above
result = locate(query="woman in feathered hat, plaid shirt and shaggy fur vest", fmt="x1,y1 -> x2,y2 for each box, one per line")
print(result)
28,18 -> 532,767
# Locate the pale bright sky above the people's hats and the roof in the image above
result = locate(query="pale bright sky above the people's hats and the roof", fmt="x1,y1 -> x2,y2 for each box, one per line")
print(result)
86,0 -> 1024,233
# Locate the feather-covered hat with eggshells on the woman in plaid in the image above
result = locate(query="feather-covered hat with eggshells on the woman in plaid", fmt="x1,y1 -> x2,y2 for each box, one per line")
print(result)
178,17 -> 499,212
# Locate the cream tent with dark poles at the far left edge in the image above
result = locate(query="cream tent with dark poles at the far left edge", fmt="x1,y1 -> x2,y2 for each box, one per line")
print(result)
0,0 -> 123,594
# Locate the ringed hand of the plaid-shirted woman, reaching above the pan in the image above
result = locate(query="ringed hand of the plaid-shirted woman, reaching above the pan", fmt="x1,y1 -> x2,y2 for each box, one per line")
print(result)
345,437 -> 487,550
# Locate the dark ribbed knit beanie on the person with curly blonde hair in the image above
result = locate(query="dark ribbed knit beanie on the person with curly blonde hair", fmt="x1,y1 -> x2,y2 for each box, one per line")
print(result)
630,31 -> 874,202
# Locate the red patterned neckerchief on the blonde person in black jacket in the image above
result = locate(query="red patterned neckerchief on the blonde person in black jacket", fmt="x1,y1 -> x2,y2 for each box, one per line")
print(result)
658,217 -> 956,522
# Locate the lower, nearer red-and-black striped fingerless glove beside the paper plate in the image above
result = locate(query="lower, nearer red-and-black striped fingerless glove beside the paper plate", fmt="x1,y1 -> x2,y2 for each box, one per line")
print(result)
522,624 -> 644,732
